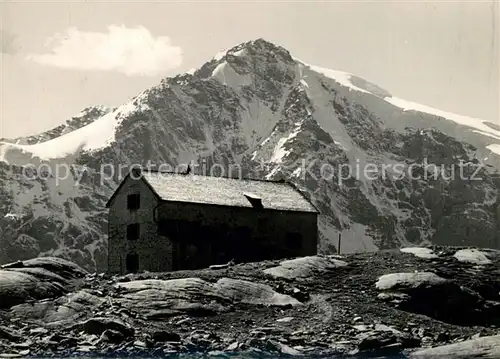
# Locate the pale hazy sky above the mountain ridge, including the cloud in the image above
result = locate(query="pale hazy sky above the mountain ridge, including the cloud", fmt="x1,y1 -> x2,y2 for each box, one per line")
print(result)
0,0 -> 500,138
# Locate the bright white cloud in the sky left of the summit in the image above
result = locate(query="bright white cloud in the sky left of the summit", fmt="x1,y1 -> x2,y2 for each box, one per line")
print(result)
27,25 -> 183,76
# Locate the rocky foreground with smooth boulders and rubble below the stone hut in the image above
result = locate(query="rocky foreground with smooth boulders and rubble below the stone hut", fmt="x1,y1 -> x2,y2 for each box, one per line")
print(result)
0,247 -> 500,358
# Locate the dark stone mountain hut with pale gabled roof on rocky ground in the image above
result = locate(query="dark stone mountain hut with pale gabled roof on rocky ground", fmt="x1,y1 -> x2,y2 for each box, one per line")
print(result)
106,169 -> 318,274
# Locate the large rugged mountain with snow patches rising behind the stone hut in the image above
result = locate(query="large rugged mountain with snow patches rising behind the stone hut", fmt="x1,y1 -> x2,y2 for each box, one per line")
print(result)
0,39 -> 500,270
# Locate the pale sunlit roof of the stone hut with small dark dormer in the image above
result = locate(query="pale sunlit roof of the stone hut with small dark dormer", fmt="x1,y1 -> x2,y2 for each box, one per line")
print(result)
106,170 -> 319,213
